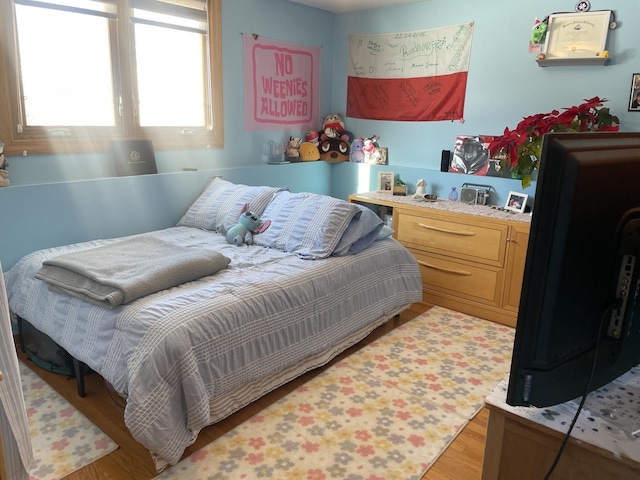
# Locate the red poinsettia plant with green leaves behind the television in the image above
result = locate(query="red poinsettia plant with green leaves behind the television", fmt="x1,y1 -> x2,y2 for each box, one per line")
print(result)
489,97 -> 620,188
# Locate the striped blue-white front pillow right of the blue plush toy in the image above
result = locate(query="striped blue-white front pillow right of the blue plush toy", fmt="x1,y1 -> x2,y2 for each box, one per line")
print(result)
253,192 -> 362,260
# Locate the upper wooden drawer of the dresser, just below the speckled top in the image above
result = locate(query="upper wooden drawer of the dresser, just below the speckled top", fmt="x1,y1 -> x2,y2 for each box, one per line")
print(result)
396,209 -> 509,266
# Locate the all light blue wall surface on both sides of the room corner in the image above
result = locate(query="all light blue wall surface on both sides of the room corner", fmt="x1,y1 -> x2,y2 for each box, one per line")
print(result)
0,0 -> 640,270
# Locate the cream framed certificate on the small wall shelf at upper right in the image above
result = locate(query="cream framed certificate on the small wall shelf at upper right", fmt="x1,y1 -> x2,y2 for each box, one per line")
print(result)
543,10 -> 611,59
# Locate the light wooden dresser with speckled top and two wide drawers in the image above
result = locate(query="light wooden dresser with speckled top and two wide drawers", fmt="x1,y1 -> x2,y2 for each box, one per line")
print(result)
349,192 -> 531,327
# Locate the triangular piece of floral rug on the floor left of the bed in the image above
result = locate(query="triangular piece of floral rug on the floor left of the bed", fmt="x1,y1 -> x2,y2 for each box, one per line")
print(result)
20,362 -> 118,480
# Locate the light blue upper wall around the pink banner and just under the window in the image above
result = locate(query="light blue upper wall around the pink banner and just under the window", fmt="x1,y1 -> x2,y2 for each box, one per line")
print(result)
9,0 -> 335,185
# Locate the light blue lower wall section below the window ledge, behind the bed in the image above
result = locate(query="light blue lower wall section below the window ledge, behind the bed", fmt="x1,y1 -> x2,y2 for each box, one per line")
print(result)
0,162 -> 330,271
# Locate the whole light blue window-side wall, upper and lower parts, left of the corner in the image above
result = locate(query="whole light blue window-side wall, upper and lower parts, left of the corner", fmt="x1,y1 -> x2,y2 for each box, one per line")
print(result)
0,0 -> 335,270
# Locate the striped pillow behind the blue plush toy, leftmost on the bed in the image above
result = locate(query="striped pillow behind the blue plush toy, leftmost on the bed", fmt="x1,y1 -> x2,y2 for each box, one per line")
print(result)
177,177 -> 287,231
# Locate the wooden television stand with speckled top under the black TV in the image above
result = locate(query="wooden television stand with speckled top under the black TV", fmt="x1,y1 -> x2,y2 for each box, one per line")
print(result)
482,366 -> 640,480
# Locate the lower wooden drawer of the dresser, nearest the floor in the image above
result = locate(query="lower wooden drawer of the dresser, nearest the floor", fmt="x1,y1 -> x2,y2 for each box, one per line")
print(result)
411,249 -> 504,306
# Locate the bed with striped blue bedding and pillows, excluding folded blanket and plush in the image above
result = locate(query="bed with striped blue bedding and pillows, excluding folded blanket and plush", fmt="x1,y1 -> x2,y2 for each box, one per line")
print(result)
5,178 -> 422,470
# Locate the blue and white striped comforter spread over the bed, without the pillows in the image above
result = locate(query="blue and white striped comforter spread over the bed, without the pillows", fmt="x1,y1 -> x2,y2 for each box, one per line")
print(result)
5,227 -> 422,468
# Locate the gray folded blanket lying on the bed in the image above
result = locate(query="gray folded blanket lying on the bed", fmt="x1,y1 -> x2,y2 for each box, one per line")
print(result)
36,235 -> 231,308
